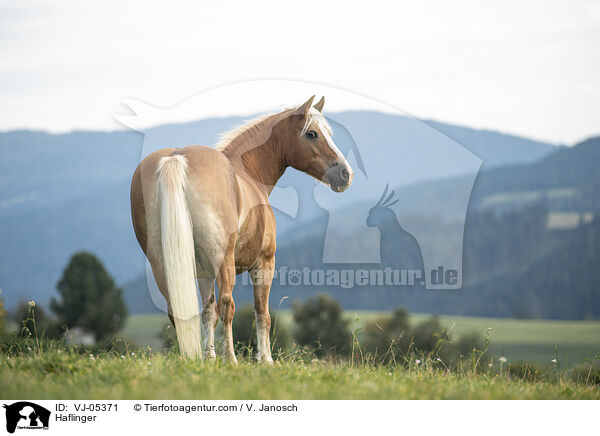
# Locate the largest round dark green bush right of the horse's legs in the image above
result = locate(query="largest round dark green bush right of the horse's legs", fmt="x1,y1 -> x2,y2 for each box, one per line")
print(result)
294,294 -> 352,356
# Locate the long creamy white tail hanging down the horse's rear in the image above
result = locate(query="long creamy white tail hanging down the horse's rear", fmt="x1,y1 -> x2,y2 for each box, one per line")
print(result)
156,155 -> 202,358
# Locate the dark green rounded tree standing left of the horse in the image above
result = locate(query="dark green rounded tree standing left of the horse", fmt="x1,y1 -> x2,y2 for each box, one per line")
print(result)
50,252 -> 127,341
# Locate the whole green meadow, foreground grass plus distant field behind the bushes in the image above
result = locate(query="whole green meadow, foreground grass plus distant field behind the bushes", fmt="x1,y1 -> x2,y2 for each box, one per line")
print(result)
0,312 -> 600,399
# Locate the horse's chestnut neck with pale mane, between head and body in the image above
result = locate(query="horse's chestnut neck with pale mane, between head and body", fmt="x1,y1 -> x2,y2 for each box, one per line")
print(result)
222,116 -> 287,195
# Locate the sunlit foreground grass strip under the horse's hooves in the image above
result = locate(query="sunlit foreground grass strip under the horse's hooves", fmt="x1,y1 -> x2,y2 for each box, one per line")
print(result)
0,349 -> 600,399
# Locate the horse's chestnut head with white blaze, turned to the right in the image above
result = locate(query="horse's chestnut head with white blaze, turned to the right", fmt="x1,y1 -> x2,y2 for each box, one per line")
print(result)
284,96 -> 353,192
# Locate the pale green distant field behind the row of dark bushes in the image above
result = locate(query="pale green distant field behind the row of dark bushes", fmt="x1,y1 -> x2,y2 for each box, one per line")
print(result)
123,311 -> 600,367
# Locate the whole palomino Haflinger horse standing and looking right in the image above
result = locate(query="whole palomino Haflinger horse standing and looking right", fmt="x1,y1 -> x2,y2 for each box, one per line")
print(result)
131,96 -> 352,363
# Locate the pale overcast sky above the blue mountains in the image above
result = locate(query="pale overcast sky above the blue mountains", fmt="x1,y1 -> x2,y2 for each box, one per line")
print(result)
0,0 -> 600,144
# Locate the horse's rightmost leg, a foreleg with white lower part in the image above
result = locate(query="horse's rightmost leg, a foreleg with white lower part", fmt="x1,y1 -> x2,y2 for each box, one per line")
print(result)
250,257 -> 275,363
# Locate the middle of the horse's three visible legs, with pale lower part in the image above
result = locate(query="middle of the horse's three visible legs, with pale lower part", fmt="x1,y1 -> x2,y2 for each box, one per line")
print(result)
217,253 -> 237,364
